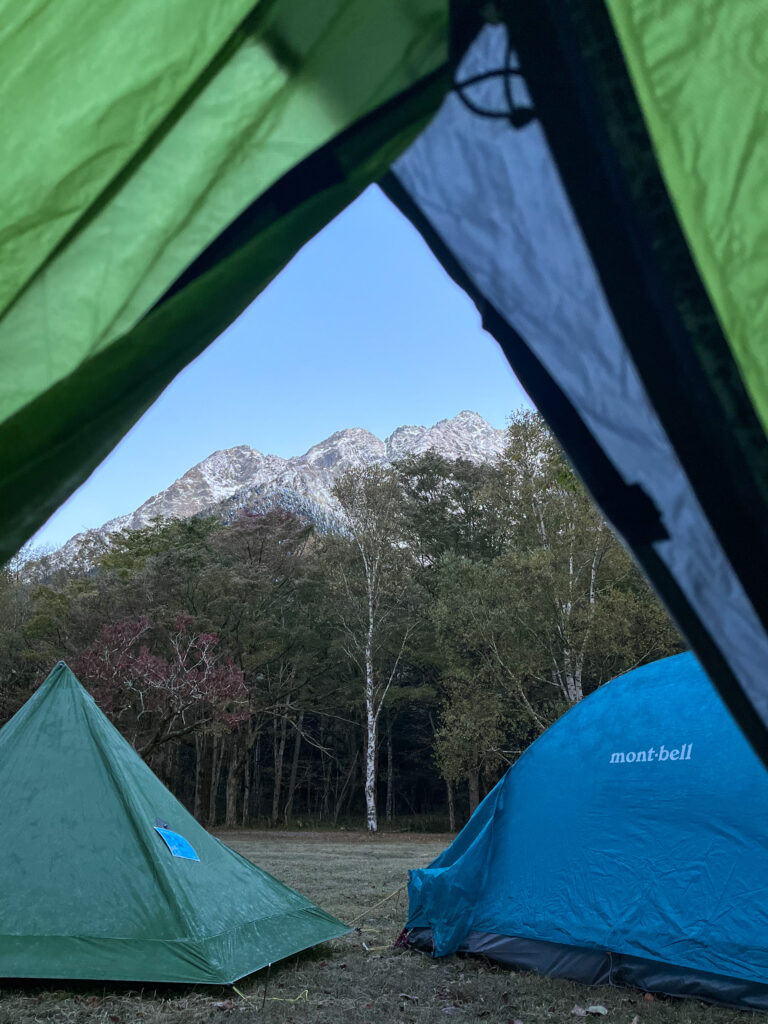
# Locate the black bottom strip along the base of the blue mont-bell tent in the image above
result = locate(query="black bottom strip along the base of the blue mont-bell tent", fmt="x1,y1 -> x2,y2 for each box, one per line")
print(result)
408,928 -> 768,1010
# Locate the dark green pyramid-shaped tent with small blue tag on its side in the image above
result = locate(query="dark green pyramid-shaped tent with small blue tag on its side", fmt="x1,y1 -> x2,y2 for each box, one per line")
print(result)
0,662 -> 348,984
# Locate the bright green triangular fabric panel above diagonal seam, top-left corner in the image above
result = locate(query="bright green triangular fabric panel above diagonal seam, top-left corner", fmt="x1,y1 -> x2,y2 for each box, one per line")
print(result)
0,0 -> 253,311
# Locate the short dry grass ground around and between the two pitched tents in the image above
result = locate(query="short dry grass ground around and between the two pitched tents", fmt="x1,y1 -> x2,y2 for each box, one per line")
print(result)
0,831 -> 749,1024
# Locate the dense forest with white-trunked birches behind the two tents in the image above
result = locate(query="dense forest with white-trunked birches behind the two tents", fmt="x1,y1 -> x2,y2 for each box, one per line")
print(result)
0,412 -> 684,831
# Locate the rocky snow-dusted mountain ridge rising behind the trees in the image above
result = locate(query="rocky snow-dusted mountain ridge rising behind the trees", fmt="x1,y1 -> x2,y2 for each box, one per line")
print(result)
58,411 -> 504,562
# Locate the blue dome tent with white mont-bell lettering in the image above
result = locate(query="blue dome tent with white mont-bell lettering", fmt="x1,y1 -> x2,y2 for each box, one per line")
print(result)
407,653 -> 768,1010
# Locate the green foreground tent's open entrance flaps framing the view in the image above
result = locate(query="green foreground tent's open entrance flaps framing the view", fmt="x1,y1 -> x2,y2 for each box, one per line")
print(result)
0,0 -> 768,760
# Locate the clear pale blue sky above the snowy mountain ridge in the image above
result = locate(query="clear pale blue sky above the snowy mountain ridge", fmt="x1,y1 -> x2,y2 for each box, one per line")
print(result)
33,187 -> 529,547
